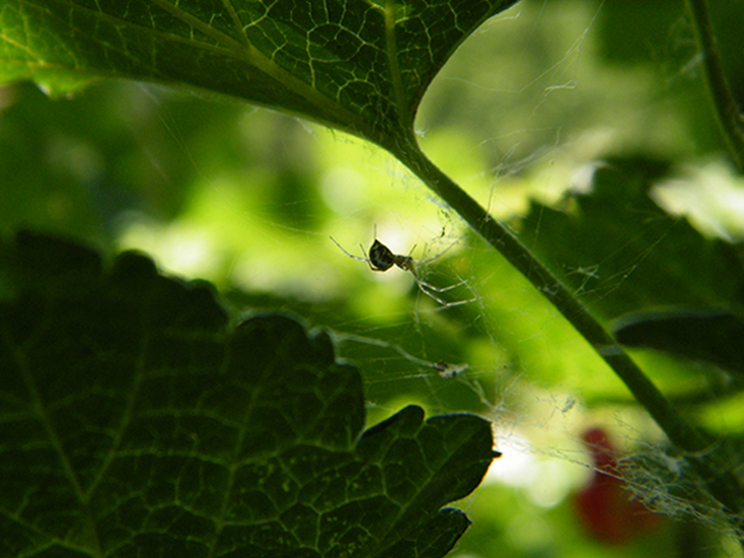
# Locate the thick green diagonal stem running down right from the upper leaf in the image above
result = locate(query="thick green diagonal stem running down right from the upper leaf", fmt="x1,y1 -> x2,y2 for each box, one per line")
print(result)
394,132 -> 744,527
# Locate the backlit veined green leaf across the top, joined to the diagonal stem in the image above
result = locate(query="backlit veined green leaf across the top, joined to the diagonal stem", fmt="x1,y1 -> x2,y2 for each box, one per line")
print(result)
0,0 -> 517,146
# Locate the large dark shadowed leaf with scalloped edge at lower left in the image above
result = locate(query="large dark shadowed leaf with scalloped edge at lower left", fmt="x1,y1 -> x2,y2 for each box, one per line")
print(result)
0,233 -> 498,558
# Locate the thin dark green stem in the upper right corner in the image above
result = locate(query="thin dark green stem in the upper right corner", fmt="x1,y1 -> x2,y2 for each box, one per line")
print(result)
687,0 -> 744,174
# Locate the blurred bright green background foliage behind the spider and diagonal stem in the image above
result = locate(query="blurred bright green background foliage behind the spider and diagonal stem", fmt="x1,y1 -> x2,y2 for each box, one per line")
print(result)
0,0 -> 744,558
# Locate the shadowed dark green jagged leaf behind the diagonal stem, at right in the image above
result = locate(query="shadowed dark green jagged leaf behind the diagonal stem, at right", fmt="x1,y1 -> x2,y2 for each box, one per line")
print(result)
520,157 -> 744,318
